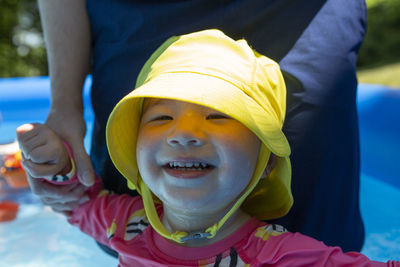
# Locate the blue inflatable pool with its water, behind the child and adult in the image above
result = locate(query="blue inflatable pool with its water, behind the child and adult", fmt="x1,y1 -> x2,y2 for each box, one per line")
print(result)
0,77 -> 400,267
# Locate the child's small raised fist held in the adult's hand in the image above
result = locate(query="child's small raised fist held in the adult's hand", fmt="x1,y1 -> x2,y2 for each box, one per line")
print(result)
17,124 -> 72,178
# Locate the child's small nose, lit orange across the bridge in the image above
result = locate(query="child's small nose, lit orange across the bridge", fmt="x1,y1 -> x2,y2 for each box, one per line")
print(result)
167,121 -> 204,146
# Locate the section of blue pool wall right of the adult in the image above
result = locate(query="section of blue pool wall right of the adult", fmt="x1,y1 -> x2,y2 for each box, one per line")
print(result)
357,84 -> 400,189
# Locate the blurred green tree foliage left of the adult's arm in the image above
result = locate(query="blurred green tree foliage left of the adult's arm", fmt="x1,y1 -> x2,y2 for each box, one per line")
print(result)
0,0 -> 47,77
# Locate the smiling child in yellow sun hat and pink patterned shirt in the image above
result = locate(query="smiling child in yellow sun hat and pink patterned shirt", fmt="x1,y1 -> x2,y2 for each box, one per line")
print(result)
17,30 -> 400,267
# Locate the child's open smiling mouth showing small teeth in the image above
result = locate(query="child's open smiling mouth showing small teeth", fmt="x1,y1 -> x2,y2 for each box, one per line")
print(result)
163,161 -> 215,179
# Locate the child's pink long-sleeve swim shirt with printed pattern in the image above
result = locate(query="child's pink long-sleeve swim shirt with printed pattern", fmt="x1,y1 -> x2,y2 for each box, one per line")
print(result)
61,176 -> 400,267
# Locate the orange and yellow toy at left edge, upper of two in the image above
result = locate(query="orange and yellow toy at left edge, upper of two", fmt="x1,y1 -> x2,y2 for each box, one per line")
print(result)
1,150 -> 29,188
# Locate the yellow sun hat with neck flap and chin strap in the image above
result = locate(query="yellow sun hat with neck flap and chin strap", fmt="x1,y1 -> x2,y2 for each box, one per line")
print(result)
106,30 -> 293,245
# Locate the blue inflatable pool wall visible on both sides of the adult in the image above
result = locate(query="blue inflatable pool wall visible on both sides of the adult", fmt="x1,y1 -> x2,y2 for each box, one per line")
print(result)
0,76 -> 400,188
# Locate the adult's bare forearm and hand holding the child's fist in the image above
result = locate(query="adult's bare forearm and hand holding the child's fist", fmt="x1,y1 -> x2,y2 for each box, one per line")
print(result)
28,0 -> 94,214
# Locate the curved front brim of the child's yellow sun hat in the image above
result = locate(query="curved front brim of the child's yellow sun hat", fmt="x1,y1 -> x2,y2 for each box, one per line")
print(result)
106,72 -> 292,219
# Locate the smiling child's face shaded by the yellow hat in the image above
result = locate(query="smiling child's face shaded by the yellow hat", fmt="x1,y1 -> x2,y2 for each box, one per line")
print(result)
136,99 -> 260,215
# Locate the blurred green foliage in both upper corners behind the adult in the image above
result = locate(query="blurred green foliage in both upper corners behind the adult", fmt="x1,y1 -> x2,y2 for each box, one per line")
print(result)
0,0 -> 400,77
